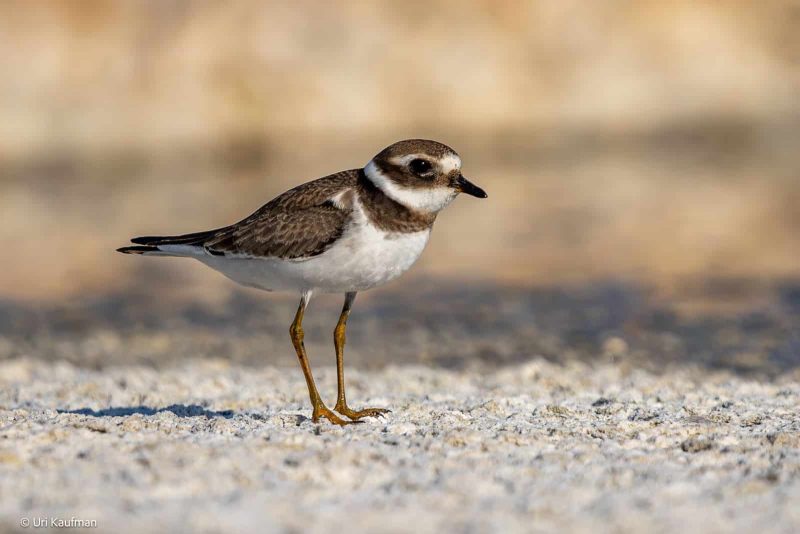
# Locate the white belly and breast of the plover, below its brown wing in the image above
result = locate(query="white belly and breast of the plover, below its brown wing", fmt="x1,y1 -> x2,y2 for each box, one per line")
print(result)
197,217 -> 431,293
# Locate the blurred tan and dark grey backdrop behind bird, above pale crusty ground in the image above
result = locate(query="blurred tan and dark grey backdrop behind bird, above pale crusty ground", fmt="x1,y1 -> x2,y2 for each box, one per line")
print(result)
0,0 -> 800,373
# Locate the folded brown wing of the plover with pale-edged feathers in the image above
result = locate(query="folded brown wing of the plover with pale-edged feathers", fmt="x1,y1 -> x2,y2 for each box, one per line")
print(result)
202,170 -> 358,259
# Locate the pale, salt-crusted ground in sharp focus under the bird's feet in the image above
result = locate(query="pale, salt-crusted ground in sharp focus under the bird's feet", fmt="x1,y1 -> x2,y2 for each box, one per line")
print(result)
0,357 -> 800,533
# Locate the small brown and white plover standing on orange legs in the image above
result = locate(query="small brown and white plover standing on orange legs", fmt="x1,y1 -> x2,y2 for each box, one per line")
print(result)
118,139 -> 487,425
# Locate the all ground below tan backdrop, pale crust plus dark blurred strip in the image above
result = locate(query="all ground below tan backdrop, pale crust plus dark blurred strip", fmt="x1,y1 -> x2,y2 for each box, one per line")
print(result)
0,281 -> 800,533
